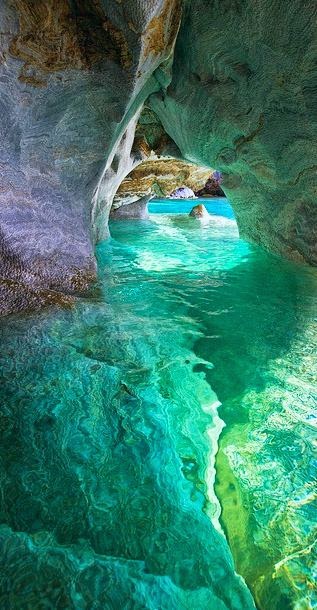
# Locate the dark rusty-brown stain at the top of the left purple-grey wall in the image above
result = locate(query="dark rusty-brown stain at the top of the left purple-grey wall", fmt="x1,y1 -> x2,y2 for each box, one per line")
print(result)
9,0 -> 121,72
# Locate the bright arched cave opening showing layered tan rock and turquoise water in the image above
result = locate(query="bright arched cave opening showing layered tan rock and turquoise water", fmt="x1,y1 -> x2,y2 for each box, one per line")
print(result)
105,158 -> 241,281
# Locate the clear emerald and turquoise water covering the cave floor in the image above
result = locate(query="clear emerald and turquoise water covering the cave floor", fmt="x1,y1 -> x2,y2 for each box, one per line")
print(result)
0,201 -> 317,610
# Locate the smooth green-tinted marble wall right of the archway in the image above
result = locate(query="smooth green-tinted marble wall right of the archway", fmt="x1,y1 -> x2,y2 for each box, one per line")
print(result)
151,0 -> 317,265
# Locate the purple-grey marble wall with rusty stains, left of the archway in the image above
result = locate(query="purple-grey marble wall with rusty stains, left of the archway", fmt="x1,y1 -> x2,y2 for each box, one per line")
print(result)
0,0 -> 179,311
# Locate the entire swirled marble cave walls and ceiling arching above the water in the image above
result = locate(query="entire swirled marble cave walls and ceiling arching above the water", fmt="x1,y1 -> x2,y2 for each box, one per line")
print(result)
0,0 -> 317,311
